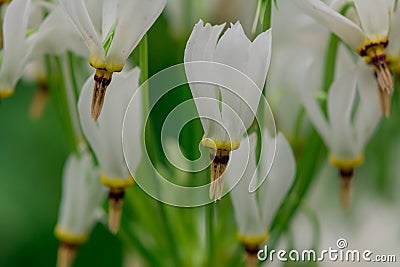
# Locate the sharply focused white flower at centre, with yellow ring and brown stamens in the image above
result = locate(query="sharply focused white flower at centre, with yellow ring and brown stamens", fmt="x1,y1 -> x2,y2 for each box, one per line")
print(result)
184,21 -> 271,199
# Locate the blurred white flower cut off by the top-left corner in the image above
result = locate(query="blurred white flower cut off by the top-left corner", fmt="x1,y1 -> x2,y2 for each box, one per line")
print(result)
0,0 -> 87,98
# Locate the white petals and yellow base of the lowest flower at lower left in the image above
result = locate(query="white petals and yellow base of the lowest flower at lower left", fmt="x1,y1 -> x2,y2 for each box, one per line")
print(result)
55,152 -> 106,245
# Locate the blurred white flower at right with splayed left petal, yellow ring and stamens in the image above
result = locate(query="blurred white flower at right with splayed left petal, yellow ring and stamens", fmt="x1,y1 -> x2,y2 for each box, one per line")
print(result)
301,59 -> 381,207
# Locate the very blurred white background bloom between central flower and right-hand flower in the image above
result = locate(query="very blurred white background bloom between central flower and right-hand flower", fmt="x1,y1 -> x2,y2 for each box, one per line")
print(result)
267,1 -> 329,141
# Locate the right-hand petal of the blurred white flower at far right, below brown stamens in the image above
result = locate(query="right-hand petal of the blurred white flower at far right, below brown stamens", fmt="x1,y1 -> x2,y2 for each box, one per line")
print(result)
354,66 -> 382,151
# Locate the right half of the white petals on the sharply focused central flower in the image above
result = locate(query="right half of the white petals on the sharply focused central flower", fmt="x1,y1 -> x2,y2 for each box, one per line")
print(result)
215,22 -> 270,137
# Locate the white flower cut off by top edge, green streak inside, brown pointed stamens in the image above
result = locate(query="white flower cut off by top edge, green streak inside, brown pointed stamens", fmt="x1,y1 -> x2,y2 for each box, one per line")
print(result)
60,0 -> 166,120
